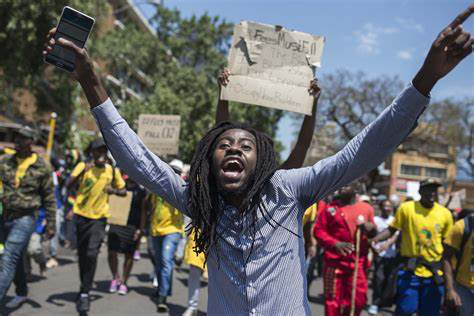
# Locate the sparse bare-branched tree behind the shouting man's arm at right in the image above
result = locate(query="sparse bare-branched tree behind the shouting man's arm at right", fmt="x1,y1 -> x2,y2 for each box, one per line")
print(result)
296,70 -> 474,188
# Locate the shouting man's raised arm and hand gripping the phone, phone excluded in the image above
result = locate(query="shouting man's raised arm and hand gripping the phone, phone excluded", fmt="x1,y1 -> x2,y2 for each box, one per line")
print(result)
43,28 -> 188,212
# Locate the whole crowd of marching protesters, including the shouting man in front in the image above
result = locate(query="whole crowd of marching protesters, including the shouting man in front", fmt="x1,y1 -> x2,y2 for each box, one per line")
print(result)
0,6 -> 474,316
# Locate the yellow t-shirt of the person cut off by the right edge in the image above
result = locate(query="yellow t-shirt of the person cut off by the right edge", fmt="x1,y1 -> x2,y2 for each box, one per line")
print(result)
444,220 -> 474,289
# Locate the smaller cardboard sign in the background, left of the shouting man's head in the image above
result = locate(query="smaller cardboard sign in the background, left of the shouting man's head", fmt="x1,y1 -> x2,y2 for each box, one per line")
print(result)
138,114 -> 181,156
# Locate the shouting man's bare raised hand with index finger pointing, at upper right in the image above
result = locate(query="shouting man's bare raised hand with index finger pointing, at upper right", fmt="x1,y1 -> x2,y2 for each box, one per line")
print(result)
413,4 -> 474,95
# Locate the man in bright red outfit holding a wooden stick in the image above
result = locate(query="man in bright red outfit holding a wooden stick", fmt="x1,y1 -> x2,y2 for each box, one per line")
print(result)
314,185 -> 376,316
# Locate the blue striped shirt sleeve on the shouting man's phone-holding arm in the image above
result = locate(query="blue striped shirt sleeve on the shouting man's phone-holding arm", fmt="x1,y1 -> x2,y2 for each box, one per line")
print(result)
92,99 -> 188,215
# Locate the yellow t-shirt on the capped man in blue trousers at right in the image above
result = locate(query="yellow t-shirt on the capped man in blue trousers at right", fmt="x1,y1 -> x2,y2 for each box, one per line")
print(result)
391,201 -> 453,278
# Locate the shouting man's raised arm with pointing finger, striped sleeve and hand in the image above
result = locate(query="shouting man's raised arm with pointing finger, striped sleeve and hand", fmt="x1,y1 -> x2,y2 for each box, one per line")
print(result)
279,5 -> 474,209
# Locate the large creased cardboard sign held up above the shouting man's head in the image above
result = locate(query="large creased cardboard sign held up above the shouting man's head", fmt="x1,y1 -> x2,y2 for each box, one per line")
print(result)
221,21 -> 324,115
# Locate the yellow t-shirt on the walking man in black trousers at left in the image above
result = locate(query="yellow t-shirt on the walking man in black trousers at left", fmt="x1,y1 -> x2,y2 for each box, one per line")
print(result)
71,162 -> 125,219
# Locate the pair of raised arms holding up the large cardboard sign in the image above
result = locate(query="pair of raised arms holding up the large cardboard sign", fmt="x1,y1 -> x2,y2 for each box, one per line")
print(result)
216,69 -> 321,169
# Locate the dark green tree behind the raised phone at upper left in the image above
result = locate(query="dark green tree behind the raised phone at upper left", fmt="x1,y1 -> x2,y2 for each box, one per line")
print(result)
0,0 -> 110,143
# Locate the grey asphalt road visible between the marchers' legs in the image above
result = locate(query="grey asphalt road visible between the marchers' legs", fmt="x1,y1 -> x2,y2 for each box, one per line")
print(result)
0,247 -> 394,316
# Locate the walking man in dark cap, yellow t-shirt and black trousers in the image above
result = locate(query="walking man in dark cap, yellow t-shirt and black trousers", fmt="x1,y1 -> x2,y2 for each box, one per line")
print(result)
66,138 -> 126,312
